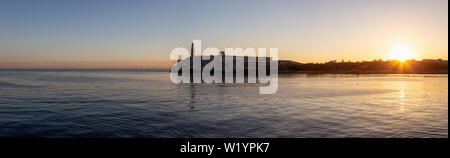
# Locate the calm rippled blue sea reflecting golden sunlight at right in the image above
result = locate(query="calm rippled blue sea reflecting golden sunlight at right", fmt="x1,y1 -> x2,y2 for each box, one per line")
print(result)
0,70 -> 448,138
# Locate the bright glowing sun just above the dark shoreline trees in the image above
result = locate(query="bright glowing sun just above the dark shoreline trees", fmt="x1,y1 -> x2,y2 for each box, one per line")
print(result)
388,44 -> 416,61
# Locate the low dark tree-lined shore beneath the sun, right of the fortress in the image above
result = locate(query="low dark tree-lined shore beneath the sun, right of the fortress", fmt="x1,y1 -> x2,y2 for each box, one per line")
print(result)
278,59 -> 448,74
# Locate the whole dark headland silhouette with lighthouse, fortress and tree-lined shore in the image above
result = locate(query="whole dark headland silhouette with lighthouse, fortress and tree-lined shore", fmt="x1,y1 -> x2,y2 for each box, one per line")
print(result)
171,43 -> 448,75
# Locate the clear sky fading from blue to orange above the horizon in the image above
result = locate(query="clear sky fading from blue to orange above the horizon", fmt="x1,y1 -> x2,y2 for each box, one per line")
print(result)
0,0 -> 448,68
